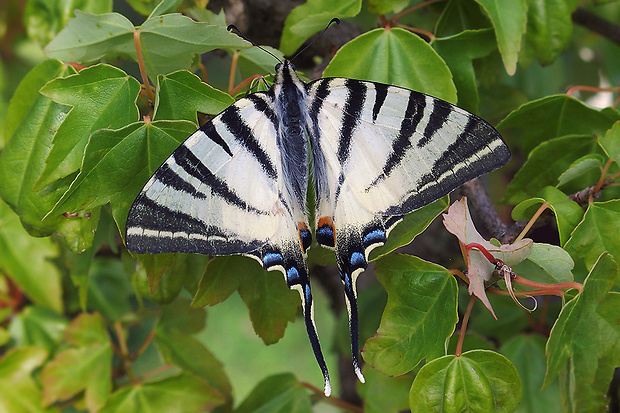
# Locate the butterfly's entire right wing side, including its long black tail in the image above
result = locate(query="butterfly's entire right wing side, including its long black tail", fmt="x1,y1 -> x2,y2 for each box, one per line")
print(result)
308,78 -> 510,379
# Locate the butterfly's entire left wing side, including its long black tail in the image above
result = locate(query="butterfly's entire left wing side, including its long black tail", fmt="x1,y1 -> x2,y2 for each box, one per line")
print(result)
126,84 -> 331,395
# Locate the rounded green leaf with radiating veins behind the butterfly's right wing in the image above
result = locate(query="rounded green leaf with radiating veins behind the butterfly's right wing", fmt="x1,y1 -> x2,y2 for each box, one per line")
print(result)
323,28 -> 457,103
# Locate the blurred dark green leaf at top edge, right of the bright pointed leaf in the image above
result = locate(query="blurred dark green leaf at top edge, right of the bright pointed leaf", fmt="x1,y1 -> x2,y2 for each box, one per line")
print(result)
519,0 -> 578,67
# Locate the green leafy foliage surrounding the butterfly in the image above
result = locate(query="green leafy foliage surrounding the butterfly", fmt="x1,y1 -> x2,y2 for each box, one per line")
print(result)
0,0 -> 620,413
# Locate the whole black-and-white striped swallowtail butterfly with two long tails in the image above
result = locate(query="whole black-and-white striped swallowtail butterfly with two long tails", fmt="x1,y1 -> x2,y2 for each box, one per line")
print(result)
126,46 -> 510,396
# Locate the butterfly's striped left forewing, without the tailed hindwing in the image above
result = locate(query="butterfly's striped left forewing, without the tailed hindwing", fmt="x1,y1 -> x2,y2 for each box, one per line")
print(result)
127,92 -> 291,254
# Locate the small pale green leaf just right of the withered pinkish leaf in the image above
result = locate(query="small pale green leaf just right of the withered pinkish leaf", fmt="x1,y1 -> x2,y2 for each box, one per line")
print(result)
513,242 -> 575,284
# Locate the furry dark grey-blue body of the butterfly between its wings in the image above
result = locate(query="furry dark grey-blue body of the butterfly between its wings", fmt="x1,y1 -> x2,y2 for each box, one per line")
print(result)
272,61 -> 309,216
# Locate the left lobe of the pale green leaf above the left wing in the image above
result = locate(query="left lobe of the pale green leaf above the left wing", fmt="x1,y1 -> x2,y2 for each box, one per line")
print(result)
44,10 -> 136,63
